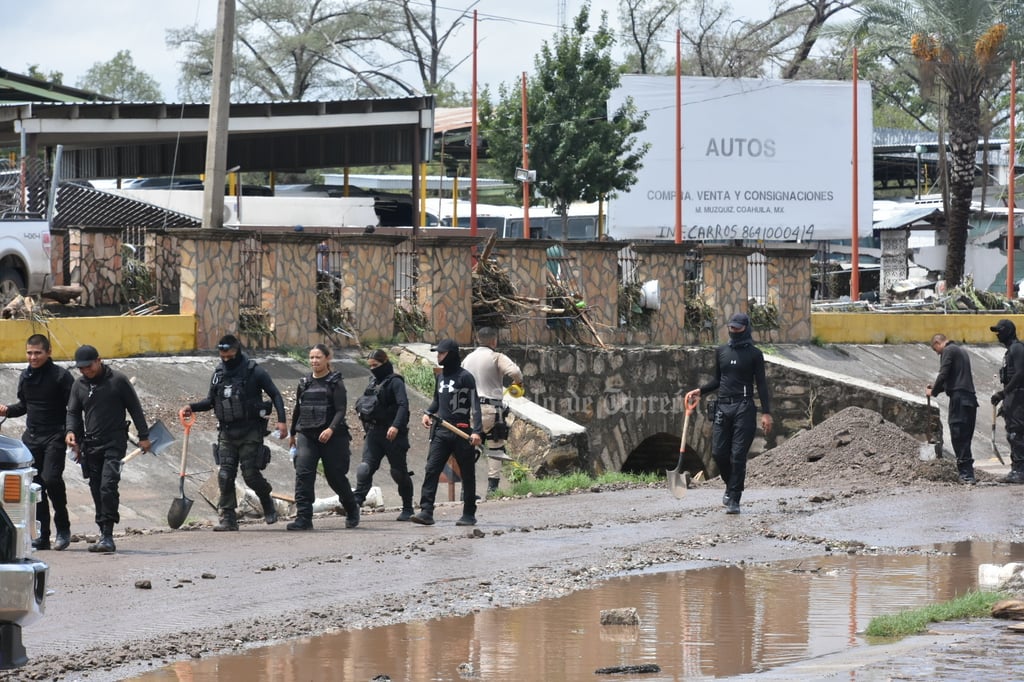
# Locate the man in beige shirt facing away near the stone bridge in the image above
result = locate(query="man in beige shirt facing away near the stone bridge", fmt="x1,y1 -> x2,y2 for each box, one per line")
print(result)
462,327 -> 522,493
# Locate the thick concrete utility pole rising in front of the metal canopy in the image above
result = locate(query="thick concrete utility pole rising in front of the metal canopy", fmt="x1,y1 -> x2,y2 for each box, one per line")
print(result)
203,0 -> 234,227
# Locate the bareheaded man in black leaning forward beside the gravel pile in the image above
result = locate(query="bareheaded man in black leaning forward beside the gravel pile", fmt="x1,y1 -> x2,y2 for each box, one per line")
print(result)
925,334 -> 978,485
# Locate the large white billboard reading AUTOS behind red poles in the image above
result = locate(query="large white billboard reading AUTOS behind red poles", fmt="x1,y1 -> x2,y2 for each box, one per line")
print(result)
608,76 -> 872,242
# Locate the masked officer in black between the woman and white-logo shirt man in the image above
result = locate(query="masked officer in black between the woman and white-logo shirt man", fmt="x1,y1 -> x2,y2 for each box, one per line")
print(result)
355,348 -> 415,521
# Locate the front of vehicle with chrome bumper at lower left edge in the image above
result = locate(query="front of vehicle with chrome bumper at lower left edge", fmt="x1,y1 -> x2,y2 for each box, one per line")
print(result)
0,435 -> 49,669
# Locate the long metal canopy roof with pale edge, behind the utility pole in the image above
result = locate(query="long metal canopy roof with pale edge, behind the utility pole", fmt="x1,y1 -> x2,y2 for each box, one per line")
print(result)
0,96 -> 434,178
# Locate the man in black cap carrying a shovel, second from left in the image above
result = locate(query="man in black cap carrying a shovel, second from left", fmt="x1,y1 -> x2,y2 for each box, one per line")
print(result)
65,346 -> 150,553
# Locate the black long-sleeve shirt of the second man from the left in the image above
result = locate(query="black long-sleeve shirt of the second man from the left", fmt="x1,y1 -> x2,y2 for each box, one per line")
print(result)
65,365 -> 150,447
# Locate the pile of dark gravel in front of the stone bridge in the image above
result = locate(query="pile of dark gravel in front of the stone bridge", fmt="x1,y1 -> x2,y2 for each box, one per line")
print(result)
746,408 -> 958,488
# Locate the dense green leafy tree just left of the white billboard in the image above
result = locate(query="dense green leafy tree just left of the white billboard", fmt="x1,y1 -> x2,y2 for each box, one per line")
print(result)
480,3 -> 647,224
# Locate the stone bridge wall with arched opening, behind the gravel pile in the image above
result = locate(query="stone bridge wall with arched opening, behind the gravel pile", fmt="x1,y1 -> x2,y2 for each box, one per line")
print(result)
503,346 -> 942,476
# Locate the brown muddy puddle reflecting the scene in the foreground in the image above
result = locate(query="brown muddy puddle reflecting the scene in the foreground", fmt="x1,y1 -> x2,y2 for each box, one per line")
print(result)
134,542 -> 1024,682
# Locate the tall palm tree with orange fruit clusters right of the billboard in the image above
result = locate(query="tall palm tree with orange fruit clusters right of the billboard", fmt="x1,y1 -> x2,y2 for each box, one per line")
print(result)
844,0 -> 1024,287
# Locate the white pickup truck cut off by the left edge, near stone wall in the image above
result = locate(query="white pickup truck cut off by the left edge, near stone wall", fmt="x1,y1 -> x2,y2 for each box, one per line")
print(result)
0,213 -> 53,306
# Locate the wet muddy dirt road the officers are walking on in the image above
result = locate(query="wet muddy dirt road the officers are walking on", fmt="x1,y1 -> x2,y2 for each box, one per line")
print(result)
14,477 -> 1024,680
